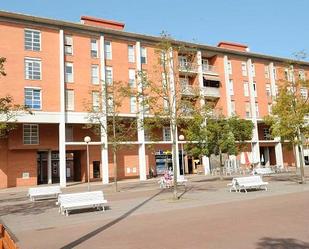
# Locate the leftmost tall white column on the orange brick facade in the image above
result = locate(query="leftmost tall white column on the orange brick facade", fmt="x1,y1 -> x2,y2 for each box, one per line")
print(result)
59,29 -> 66,187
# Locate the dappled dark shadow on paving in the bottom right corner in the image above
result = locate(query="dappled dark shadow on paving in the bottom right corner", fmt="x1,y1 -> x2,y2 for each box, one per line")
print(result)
256,237 -> 309,249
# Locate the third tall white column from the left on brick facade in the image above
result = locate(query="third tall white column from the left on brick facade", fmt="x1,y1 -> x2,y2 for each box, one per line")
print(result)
135,42 -> 147,181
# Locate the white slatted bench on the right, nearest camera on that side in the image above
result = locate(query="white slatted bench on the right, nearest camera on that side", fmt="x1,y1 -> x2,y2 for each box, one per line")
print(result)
228,175 -> 268,193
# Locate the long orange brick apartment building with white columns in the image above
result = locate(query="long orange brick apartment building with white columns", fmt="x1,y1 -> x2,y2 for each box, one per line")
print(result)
0,11 -> 309,188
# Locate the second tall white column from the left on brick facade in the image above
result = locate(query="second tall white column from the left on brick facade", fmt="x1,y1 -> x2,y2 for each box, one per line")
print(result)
100,35 -> 109,184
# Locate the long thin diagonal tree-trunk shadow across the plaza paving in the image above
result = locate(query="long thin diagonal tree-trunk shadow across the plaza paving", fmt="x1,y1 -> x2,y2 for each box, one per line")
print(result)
61,190 -> 164,249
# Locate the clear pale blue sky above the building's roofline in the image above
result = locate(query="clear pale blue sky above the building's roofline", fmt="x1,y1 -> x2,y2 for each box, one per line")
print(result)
0,0 -> 309,60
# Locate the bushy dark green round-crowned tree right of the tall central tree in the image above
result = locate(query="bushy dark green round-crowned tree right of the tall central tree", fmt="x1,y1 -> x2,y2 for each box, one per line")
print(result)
184,110 -> 254,179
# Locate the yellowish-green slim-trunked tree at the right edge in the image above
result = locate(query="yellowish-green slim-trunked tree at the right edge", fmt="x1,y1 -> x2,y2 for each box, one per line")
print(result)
264,62 -> 309,183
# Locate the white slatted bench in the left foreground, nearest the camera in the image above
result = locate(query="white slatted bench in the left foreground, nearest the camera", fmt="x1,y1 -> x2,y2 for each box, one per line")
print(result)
57,191 -> 107,216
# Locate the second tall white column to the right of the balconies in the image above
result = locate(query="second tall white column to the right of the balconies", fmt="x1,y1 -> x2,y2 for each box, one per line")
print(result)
247,59 -> 260,166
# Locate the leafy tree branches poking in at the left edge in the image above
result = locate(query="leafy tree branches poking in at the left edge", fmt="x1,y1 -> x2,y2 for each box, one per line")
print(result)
0,57 -> 32,138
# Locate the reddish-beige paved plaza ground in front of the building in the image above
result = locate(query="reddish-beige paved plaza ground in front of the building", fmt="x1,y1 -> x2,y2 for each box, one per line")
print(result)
0,170 -> 309,249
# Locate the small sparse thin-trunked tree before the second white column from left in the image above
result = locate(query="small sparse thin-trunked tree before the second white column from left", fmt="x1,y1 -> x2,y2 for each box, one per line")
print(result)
87,79 -> 137,192
